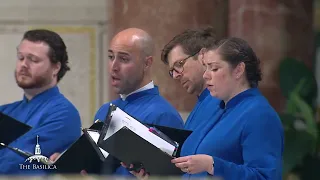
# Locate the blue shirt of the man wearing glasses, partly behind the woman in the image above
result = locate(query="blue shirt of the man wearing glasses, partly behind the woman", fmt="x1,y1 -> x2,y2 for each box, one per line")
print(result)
184,89 -> 221,130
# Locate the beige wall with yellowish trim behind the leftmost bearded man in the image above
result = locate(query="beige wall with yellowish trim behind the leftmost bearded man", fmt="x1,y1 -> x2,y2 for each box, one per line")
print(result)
0,0 -> 111,127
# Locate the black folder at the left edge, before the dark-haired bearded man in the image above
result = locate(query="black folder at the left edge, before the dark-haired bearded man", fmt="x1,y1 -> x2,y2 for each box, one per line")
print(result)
0,112 -> 32,149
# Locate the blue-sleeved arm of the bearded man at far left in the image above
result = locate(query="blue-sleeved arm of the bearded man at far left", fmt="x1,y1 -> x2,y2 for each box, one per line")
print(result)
1,104 -> 81,174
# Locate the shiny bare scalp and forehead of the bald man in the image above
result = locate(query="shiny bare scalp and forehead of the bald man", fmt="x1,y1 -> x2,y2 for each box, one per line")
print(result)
111,28 -> 155,56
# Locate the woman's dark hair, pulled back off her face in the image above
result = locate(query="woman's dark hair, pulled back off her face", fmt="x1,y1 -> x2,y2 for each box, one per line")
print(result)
207,37 -> 262,87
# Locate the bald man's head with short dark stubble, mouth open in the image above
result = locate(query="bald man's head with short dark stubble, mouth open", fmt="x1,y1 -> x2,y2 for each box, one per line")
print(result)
108,28 -> 154,94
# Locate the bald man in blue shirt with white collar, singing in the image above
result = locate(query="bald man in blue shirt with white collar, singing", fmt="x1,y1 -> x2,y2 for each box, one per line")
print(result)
94,28 -> 184,176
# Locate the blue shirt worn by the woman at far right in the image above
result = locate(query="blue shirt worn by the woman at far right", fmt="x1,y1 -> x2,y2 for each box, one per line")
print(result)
181,88 -> 284,180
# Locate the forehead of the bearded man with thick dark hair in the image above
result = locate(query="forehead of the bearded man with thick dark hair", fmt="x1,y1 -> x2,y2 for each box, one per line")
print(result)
17,40 -> 49,56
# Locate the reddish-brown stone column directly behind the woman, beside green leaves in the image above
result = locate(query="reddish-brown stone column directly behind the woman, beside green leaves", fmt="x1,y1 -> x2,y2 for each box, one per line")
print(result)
228,0 -> 314,110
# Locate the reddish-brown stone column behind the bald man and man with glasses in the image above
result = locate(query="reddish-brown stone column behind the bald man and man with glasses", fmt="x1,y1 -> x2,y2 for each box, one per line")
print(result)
110,0 -> 228,115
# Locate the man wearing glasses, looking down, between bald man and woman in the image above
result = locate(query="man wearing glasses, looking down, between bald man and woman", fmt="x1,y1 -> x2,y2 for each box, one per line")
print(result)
161,27 -> 220,130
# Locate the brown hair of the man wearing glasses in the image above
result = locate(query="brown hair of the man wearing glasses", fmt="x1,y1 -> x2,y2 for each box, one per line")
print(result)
161,27 -> 216,64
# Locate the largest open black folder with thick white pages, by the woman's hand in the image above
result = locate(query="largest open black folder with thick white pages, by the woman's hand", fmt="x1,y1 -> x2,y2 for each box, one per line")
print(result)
98,104 -> 192,176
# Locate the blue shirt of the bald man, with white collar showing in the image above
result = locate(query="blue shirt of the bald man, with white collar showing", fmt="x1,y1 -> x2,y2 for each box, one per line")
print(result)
95,86 -> 184,176
